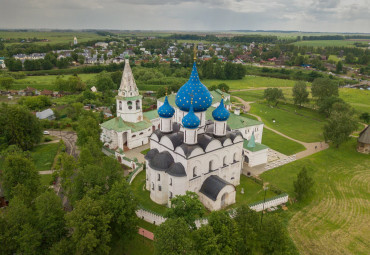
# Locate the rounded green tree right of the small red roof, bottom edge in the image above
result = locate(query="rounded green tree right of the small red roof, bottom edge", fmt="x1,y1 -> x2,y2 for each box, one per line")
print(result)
154,218 -> 192,255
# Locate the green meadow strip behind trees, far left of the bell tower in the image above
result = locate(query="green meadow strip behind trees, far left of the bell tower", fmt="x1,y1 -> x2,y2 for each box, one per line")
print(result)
11,74 -> 96,90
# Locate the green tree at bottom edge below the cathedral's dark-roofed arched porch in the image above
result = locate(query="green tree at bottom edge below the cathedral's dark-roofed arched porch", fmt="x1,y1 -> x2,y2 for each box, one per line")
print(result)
208,211 -> 239,255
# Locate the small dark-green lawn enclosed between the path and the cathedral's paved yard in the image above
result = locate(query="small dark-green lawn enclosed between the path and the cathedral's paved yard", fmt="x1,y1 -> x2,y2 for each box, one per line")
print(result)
262,128 -> 306,155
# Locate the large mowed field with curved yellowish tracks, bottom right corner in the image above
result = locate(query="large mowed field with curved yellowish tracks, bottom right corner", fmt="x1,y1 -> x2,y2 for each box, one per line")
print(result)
262,139 -> 370,254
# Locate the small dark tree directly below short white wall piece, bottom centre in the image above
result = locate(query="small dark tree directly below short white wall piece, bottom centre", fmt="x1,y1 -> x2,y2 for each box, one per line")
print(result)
193,225 -> 222,255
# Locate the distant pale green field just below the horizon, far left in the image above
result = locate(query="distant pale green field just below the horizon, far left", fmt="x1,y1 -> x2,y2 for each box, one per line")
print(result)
0,31 -> 105,45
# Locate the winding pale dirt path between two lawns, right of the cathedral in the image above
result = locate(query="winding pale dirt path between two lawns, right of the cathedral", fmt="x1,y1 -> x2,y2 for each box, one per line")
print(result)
233,96 -> 329,159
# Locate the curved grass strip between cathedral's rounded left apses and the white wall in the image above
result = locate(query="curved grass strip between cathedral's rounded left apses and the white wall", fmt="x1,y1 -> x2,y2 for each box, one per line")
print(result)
131,171 -> 167,215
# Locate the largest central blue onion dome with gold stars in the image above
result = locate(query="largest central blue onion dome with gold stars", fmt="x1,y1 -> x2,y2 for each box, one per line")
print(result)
175,62 -> 212,112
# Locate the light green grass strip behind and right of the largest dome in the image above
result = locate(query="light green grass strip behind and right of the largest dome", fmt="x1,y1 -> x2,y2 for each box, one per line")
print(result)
202,75 -> 295,90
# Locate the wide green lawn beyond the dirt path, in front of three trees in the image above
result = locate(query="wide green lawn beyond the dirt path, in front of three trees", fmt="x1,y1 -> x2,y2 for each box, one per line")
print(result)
250,103 -> 325,142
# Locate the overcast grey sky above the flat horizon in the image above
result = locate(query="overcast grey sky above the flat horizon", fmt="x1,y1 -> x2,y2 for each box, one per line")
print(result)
0,0 -> 370,33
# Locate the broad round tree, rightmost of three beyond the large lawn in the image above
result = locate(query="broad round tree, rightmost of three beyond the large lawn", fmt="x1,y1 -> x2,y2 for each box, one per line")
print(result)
311,78 -> 339,101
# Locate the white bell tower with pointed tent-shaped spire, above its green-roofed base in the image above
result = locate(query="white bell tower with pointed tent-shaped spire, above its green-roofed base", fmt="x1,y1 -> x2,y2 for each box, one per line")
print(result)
116,58 -> 143,123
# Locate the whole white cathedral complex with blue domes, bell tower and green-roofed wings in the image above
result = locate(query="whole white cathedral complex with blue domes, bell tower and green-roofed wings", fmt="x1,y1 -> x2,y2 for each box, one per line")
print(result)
101,59 -> 268,210
